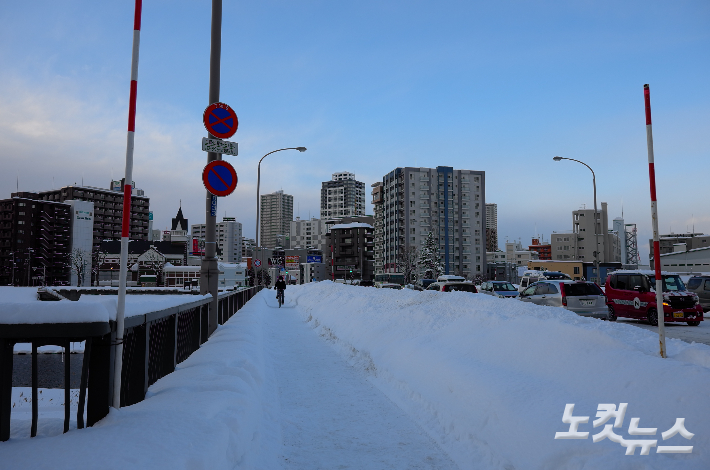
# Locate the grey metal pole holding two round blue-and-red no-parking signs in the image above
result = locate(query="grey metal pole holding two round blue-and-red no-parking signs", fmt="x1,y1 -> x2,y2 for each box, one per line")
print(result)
200,0 -> 222,333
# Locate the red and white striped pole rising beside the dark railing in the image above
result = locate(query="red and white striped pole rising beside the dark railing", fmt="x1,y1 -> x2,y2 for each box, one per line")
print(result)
113,0 -> 143,409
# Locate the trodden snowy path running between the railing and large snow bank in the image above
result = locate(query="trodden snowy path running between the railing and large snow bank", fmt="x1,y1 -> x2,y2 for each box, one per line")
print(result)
259,289 -> 458,470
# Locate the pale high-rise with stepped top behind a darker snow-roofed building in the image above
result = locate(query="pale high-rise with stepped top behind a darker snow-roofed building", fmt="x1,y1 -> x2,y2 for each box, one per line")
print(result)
320,171 -> 365,219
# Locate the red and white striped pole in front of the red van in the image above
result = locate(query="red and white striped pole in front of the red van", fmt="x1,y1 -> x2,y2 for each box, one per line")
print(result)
643,84 -> 666,357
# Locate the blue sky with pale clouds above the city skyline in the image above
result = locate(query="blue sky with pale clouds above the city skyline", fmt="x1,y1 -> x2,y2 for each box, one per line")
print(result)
0,0 -> 710,260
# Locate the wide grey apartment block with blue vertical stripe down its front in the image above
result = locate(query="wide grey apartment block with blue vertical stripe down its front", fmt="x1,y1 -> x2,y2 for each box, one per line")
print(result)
382,166 -> 486,277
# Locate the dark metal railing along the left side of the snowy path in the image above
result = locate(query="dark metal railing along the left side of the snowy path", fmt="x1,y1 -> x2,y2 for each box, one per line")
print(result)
0,286 -> 263,441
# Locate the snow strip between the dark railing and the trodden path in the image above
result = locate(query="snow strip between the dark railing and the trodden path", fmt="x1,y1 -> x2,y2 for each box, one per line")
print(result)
0,296 -> 281,470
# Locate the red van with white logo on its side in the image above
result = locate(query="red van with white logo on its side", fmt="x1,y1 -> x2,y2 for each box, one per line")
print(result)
606,270 -> 703,326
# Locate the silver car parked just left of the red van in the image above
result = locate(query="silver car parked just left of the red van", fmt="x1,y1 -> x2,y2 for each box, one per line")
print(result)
520,279 -> 610,319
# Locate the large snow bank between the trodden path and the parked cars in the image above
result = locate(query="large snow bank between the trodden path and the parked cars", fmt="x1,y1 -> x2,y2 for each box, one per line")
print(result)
289,281 -> 710,469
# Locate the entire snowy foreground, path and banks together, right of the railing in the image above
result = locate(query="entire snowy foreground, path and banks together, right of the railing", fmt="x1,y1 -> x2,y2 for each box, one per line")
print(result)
0,282 -> 710,469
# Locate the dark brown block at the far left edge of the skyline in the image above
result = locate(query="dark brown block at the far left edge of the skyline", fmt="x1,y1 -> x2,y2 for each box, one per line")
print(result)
0,192 -> 71,286
